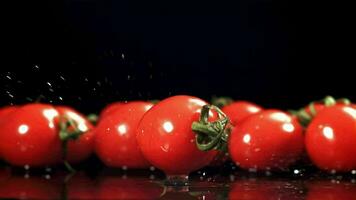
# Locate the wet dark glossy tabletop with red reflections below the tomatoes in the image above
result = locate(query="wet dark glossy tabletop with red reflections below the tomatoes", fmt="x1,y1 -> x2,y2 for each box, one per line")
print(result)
0,167 -> 356,200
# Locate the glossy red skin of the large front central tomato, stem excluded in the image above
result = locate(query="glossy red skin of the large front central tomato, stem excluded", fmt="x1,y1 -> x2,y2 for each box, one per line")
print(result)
137,95 -> 217,175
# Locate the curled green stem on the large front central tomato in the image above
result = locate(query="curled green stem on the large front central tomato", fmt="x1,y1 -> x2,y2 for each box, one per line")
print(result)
192,105 -> 230,151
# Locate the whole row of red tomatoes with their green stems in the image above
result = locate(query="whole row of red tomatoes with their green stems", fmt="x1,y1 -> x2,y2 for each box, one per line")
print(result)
0,95 -> 356,176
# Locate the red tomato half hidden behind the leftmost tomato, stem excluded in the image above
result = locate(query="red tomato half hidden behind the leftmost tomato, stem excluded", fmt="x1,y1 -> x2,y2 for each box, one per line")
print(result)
55,106 -> 95,163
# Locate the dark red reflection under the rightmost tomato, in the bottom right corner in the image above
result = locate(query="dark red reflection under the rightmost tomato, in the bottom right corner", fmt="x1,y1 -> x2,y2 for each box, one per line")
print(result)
306,181 -> 356,200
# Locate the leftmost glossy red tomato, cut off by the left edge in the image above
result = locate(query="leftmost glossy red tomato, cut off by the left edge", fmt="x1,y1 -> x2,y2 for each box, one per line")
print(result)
0,103 -> 61,166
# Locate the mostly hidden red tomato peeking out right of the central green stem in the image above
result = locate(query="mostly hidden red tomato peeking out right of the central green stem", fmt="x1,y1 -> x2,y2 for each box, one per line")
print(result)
222,101 -> 262,126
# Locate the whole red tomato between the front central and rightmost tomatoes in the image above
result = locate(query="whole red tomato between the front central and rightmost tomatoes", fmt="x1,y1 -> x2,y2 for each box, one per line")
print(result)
228,110 -> 304,170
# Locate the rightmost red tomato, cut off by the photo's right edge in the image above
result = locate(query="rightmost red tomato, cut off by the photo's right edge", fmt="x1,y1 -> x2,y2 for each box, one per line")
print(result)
305,105 -> 356,171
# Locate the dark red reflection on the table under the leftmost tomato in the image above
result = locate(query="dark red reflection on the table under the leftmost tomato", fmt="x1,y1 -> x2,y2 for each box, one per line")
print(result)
0,176 -> 61,199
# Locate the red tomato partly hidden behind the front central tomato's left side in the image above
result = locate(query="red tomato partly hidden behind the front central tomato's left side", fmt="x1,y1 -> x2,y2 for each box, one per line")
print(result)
95,101 -> 153,168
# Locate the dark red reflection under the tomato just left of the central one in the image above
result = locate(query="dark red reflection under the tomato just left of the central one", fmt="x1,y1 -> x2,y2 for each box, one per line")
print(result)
95,176 -> 163,199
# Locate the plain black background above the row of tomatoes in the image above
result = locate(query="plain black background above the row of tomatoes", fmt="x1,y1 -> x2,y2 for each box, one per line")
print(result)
0,0 -> 356,113
